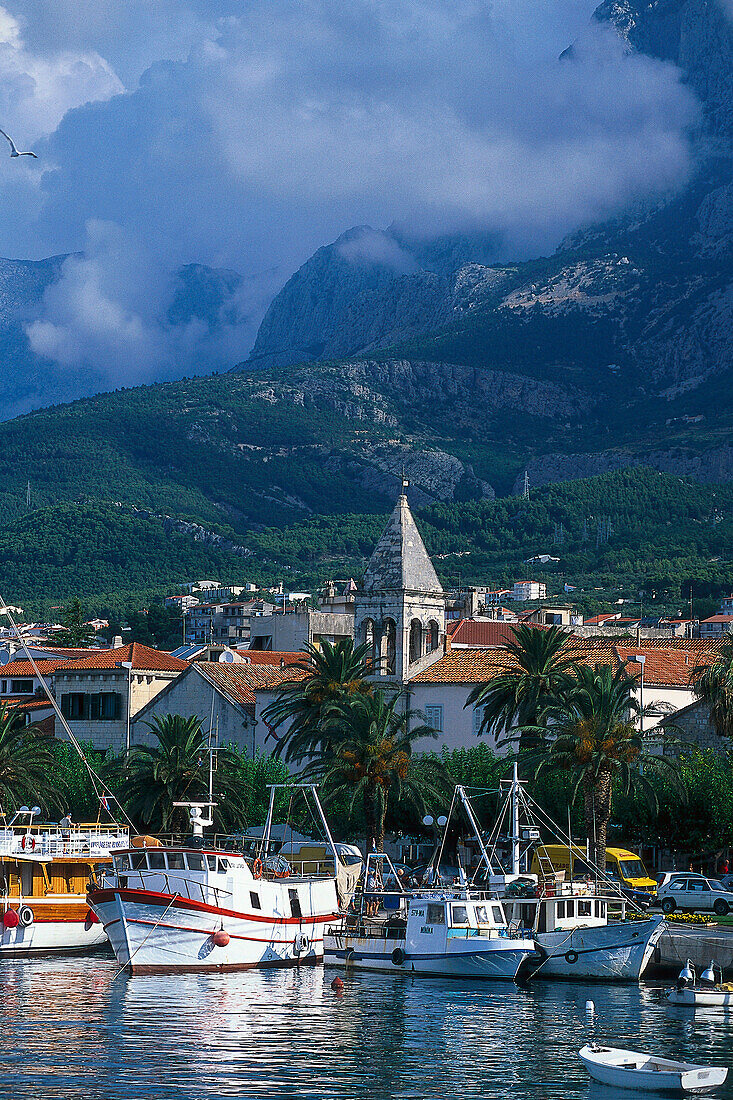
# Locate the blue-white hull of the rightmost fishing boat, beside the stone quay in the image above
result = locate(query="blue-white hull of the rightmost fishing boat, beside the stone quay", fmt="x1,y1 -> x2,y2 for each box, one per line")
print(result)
532,916 -> 665,981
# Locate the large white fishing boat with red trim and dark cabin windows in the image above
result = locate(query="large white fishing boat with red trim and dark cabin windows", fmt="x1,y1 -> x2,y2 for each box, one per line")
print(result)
89,785 -> 361,974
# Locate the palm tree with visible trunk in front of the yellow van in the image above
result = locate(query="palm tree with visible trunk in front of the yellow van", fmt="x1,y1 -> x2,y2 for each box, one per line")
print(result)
512,664 -> 685,870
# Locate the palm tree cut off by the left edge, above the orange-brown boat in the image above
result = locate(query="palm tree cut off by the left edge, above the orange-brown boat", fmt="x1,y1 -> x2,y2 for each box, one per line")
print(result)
0,703 -> 59,813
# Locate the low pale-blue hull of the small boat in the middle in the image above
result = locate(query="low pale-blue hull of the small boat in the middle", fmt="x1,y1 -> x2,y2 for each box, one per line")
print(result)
324,928 -> 534,981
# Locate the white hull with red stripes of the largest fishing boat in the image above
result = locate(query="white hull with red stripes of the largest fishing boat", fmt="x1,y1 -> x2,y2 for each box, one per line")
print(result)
89,882 -> 338,974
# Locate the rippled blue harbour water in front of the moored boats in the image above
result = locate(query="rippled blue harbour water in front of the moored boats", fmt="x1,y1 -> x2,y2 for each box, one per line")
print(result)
0,956 -> 733,1100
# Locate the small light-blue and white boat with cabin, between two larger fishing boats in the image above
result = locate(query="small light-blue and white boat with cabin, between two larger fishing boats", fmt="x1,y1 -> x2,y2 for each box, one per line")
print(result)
324,854 -> 535,981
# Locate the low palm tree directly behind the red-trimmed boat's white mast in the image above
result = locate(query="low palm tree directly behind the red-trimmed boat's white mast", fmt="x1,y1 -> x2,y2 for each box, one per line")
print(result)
117,714 -> 245,833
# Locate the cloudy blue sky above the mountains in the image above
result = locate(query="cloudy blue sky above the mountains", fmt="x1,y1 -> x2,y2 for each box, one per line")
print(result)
0,0 -> 697,384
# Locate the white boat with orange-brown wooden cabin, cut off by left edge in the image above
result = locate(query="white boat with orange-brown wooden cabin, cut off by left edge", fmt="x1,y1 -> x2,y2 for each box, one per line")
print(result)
0,806 -> 130,957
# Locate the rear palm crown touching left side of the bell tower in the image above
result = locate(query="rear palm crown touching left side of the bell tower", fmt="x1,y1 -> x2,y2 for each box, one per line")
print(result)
262,638 -> 372,763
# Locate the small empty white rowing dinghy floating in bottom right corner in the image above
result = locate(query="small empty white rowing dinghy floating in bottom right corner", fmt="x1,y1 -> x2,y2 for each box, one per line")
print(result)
578,1046 -> 727,1093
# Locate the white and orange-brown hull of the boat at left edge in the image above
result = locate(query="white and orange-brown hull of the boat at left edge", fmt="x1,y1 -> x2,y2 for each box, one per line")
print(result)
0,897 -> 107,958
